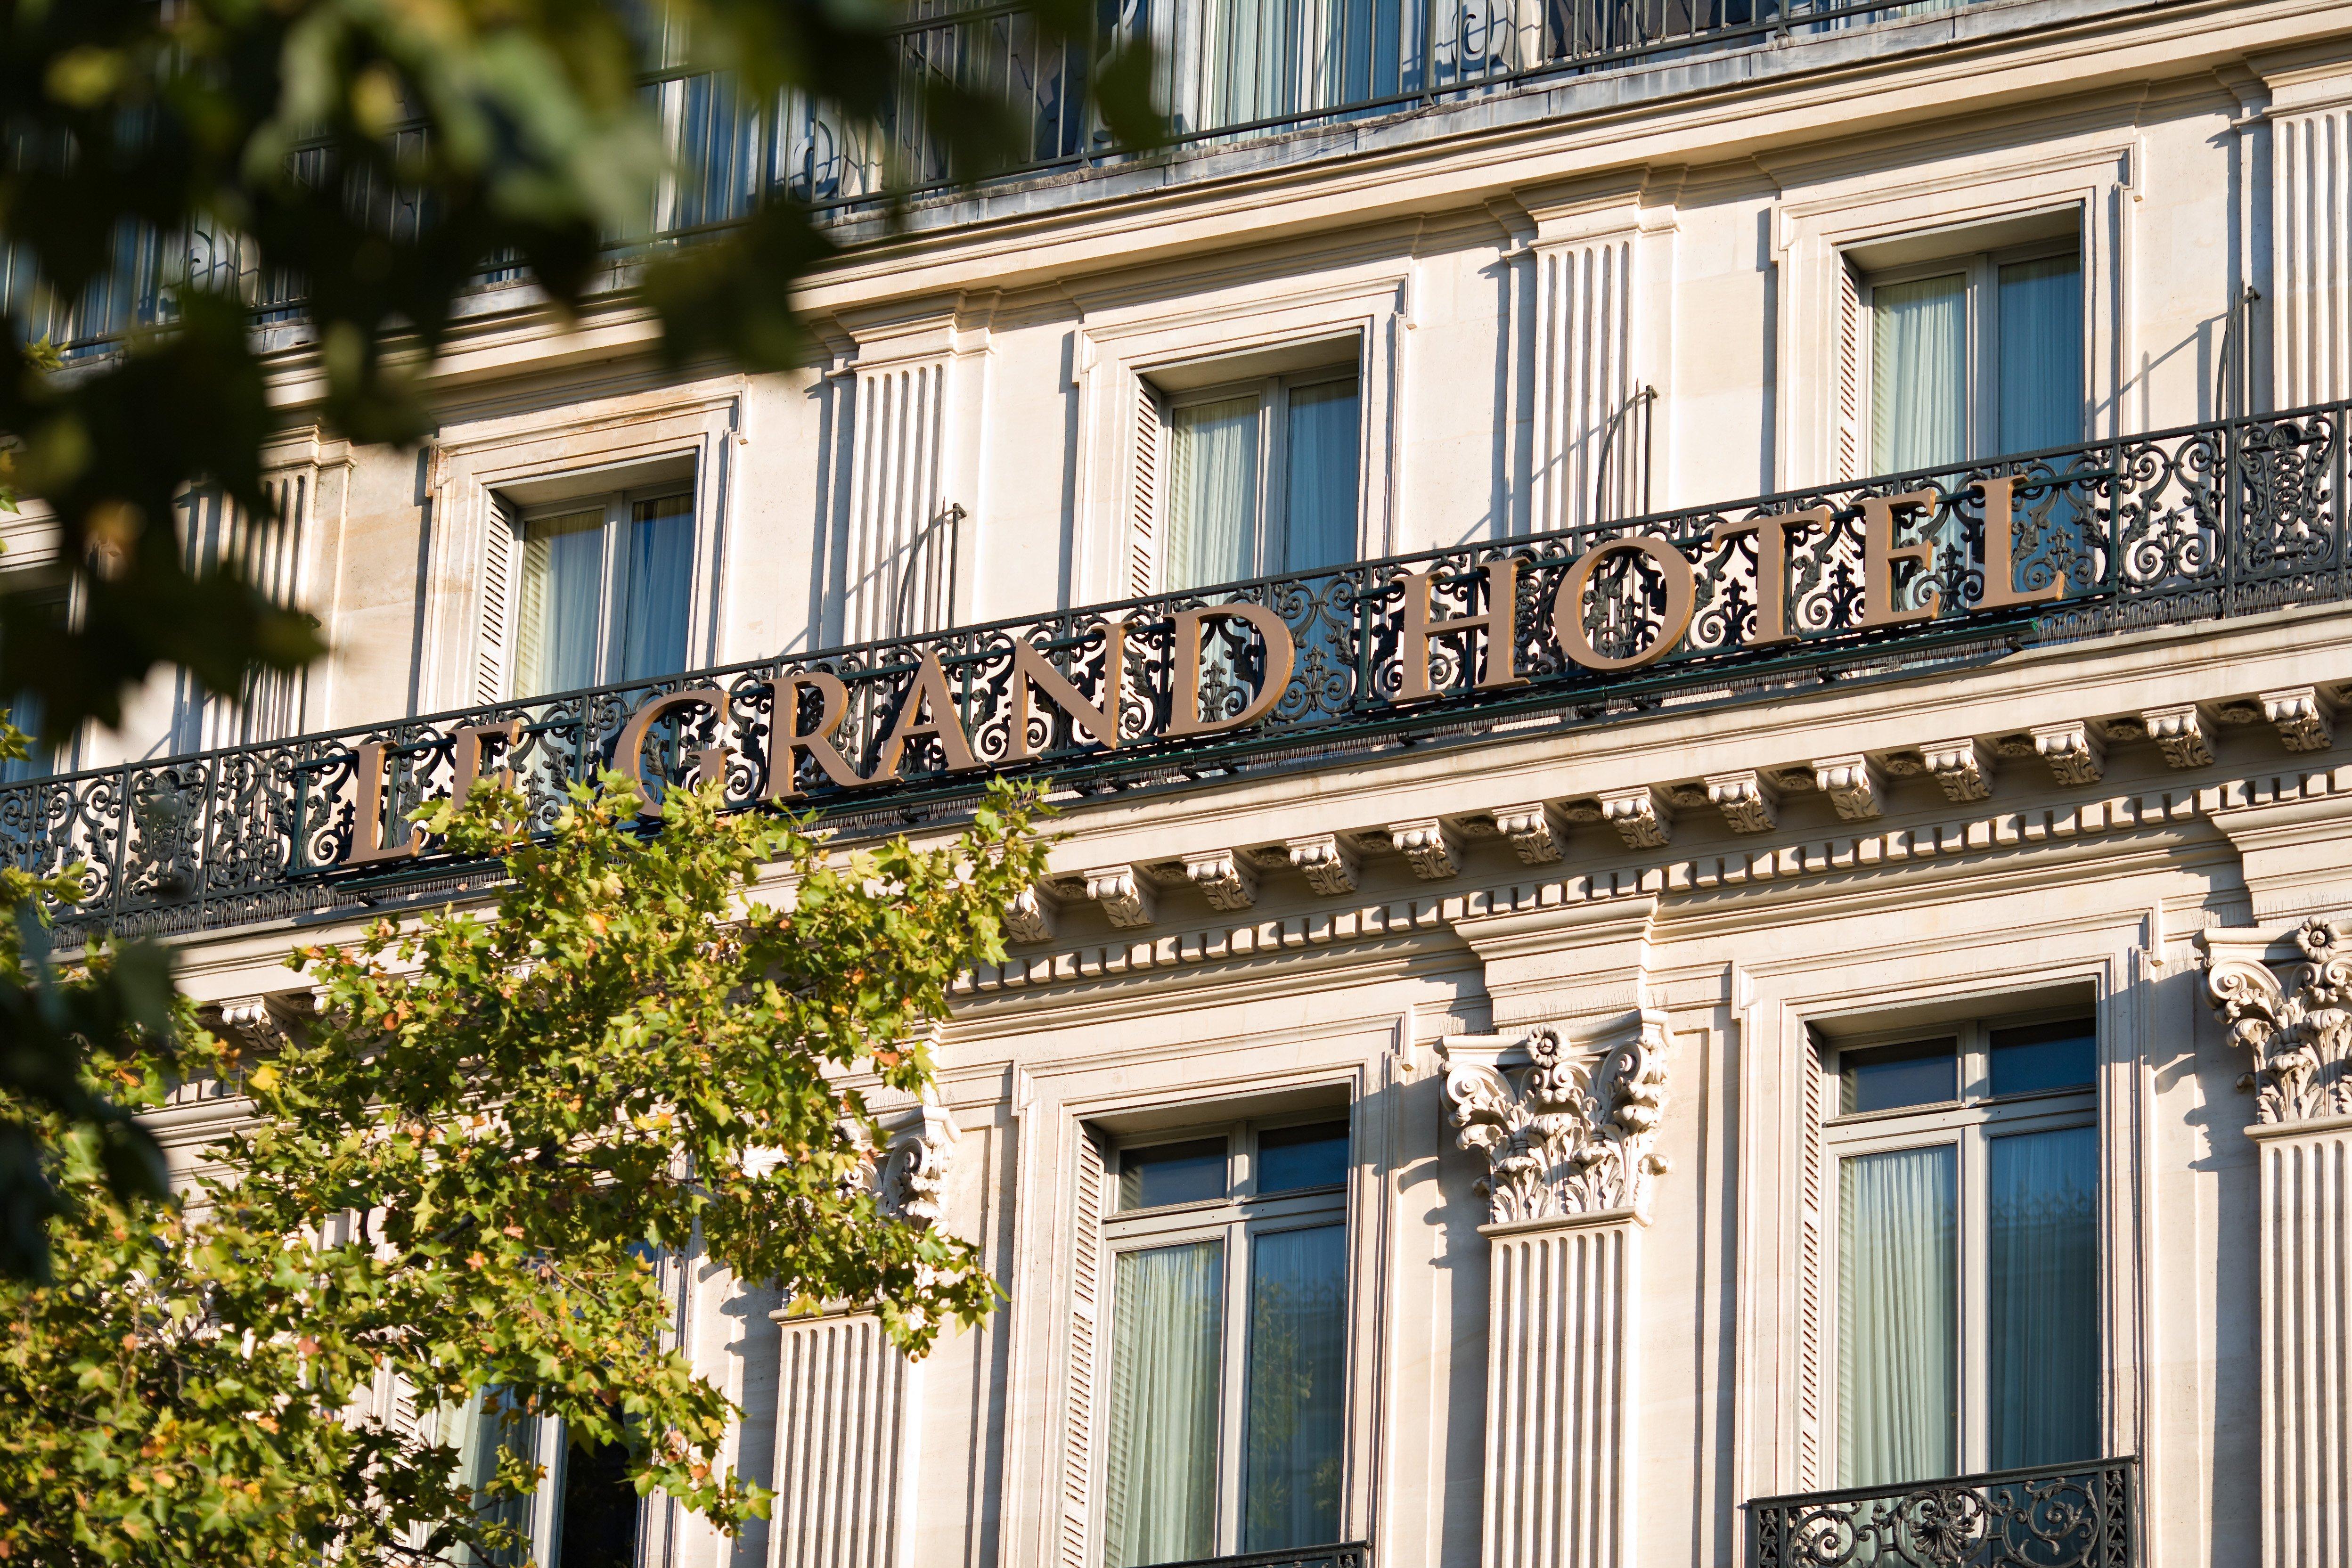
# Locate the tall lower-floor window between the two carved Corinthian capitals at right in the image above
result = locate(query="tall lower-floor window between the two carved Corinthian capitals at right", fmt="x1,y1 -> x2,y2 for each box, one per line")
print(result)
1823,1018 -> 2100,1486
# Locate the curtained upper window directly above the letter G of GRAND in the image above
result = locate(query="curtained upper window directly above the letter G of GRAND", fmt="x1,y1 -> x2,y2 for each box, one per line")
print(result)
510,494 -> 694,696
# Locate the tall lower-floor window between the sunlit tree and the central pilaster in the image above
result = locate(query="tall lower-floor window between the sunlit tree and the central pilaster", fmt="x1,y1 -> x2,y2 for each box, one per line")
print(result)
1103,1121 -> 1348,1568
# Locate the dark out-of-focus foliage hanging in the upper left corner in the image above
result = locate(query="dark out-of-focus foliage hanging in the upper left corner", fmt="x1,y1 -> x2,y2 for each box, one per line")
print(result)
0,0 -> 1160,1272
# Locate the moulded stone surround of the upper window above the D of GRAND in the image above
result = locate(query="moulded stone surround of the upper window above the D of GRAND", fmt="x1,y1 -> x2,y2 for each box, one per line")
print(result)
1072,256 -> 1411,602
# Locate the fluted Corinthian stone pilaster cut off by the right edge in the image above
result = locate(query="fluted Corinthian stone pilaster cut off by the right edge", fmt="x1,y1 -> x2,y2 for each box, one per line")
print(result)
2206,917 -> 2352,1568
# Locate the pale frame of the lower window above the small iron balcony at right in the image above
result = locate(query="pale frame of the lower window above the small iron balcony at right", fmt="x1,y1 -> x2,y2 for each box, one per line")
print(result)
1816,1006 -> 2115,1478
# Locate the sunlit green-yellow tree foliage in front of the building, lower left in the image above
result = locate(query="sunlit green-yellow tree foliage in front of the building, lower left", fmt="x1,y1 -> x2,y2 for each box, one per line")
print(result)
0,776 -> 1042,1568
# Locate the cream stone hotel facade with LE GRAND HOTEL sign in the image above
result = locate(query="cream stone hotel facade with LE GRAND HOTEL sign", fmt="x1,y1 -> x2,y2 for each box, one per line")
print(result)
23,0 -> 2352,1568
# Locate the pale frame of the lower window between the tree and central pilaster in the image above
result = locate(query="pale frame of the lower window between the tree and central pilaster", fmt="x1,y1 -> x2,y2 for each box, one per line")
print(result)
1089,1107 -> 1359,1568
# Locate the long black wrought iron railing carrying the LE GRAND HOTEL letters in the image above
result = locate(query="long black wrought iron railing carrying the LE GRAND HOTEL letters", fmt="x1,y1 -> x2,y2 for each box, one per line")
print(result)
0,402 -> 2352,936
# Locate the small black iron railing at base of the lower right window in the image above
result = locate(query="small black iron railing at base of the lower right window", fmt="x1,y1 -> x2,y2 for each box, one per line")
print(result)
1748,1460 -> 2140,1568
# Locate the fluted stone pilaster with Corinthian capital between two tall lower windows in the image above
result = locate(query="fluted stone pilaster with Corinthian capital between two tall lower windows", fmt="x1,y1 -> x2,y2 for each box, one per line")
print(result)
1444,1008 -> 1665,1568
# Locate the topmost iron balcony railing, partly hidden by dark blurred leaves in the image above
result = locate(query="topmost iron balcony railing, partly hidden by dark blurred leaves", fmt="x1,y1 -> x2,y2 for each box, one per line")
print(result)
0,0 -> 1971,355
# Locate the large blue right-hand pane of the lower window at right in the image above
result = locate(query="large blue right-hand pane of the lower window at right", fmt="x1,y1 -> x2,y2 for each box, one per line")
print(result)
1985,1126 -> 2098,1469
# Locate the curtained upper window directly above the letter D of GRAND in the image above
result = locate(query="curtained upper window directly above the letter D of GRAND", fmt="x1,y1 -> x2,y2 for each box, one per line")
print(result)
1160,364 -> 1362,592
